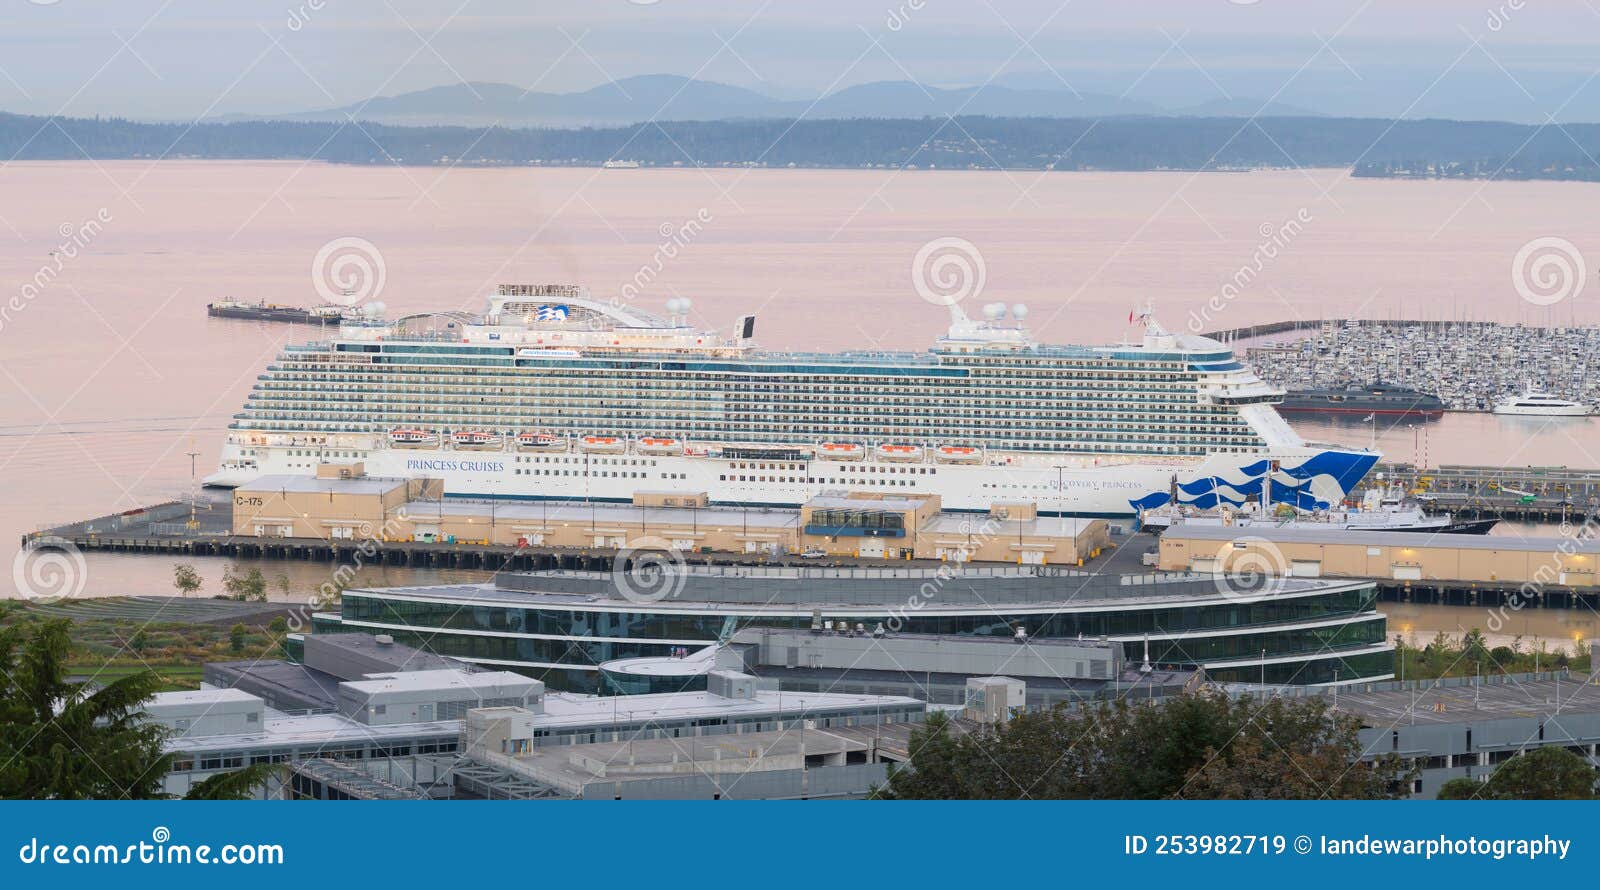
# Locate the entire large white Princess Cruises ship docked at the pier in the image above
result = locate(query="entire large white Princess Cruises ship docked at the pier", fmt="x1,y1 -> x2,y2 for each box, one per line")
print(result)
206,285 -> 1378,517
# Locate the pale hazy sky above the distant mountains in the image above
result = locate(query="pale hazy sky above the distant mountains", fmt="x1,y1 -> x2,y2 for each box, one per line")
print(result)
9,0 -> 1600,120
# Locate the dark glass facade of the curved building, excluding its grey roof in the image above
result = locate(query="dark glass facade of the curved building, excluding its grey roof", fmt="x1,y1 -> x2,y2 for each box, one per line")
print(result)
331,587 -> 1392,692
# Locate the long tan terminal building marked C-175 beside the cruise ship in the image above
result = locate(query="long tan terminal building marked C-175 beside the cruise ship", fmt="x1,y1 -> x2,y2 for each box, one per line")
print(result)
234,464 -> 1110,565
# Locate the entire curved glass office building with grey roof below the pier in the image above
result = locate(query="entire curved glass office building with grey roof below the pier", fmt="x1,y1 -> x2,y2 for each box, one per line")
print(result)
317,567 -> 1394,692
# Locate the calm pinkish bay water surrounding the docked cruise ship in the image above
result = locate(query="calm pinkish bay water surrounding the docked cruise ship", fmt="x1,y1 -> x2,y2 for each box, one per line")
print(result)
0,162 -> 1600,637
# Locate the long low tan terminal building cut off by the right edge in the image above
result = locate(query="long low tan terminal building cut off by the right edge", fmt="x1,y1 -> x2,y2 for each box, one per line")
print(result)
1160,523 -> 1600,587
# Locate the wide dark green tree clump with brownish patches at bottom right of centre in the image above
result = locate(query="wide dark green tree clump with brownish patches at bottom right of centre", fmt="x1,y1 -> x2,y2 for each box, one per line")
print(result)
877,693 -> 1410,799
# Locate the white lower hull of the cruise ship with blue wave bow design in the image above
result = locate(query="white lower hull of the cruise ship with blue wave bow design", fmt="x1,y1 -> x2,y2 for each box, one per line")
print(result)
205,443 -> 1378,517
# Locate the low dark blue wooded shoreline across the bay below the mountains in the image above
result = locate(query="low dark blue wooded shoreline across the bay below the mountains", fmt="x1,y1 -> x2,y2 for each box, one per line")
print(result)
9,114 -> 1600,181
